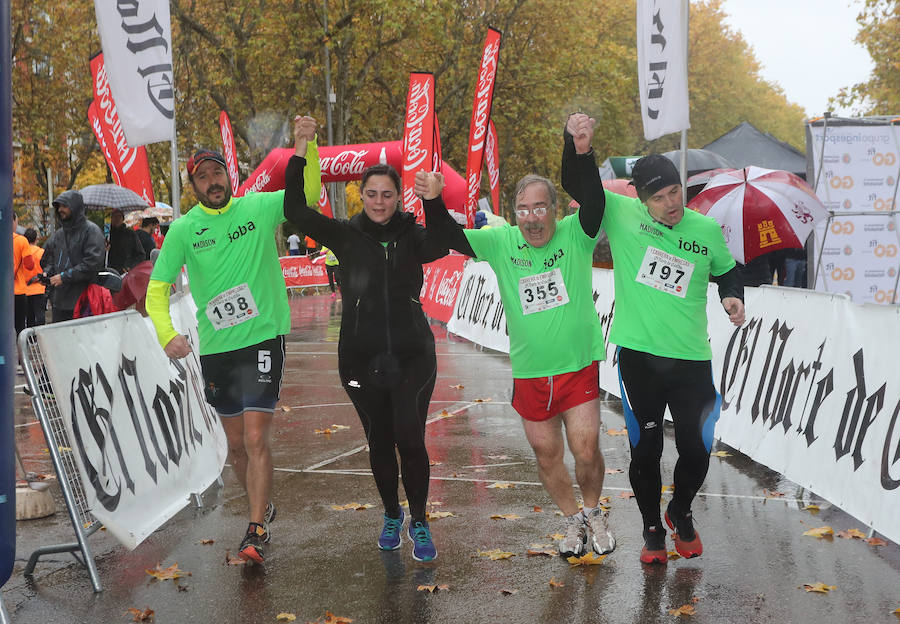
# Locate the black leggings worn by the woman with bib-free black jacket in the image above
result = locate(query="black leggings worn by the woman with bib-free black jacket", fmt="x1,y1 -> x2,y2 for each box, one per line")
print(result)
338,351 -> 437,522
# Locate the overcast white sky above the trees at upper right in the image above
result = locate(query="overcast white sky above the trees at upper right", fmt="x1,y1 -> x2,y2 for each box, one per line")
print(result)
722,0 -> 872,117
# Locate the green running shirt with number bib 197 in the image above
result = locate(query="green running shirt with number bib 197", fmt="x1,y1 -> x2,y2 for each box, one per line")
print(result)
602,192 -> 735,360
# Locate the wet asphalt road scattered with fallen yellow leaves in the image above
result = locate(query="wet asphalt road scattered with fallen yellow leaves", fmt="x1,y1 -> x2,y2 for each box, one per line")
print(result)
3,295 -> 900,624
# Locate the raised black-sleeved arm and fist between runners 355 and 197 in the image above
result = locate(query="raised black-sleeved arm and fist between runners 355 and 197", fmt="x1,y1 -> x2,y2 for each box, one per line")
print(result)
561,113 -> 606,238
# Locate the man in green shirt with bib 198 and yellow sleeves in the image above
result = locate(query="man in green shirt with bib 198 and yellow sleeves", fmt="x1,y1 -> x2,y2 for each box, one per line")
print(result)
147,117 -> 321,563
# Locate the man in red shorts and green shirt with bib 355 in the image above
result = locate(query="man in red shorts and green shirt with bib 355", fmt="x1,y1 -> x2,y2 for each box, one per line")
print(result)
416,111 -> 616,557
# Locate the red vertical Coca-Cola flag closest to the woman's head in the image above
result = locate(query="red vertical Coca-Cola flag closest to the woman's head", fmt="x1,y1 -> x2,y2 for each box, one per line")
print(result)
401,72 -> 435,223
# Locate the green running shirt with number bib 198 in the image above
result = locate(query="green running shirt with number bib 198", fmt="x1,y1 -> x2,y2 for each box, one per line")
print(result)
150,191 -> 291,355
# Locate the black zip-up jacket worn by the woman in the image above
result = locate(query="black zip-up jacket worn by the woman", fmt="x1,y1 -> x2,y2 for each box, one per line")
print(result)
284,155 -> 448,356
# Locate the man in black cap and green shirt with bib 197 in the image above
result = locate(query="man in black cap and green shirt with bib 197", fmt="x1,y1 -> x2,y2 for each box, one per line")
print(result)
562,113 -> 744,563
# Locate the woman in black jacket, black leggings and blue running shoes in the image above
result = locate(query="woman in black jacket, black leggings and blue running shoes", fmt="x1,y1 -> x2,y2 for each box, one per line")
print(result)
284,129 -> 448,561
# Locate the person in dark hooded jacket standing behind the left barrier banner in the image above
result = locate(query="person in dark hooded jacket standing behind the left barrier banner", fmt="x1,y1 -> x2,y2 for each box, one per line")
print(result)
41,191 -> 106,323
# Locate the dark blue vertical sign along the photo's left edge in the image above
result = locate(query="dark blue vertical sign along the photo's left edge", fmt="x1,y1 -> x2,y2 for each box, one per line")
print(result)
0,0 -> 16,585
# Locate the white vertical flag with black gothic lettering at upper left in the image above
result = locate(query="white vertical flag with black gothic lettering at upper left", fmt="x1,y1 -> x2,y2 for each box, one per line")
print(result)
94,0 -> 175,147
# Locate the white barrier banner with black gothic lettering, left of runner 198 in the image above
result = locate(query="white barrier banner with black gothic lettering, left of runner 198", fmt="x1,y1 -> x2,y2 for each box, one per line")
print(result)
36,296 -> 227,549
